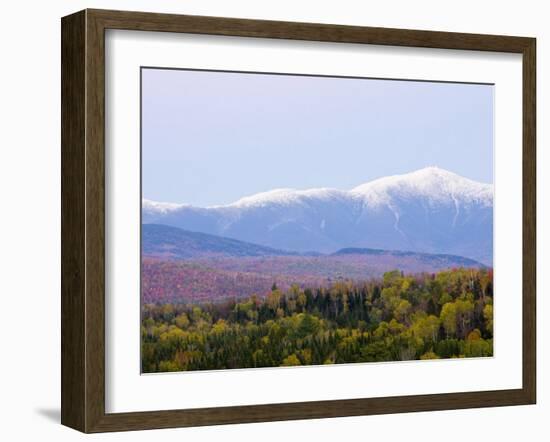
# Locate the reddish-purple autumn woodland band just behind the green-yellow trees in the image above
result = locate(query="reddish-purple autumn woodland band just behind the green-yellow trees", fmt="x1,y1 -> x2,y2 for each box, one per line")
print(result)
142,254 -> 492,303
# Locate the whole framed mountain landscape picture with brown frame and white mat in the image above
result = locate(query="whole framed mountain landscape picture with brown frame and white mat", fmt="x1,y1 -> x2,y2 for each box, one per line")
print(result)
61,10 -> 536,432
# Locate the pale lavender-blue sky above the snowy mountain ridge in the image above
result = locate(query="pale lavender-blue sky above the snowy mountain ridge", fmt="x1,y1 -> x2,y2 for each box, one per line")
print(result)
142,69 -> 494,206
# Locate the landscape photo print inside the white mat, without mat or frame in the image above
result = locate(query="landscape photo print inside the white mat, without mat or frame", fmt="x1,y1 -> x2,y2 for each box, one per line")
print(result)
141,67 -> 494,373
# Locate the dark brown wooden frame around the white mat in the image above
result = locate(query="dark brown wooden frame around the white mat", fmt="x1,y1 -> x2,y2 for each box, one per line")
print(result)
61,10 -> 536,432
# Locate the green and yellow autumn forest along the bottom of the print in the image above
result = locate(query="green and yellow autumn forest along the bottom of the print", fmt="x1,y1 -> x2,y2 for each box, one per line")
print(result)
141,269 -> 493,373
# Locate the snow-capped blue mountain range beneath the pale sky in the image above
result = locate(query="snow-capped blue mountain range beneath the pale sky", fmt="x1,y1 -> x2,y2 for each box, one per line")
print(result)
142,167 -> 493,265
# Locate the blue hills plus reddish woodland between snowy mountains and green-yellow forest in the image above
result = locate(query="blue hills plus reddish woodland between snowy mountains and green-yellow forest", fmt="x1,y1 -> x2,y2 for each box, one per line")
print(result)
142,224 -> 484,302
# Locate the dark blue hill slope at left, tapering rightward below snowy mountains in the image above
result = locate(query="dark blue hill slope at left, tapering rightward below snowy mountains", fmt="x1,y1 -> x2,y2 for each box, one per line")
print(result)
141,224 -> 296,259
